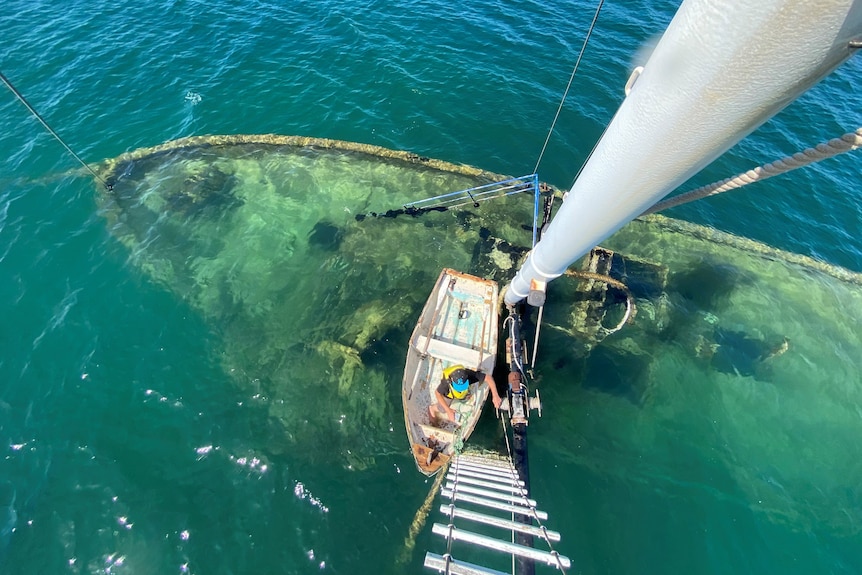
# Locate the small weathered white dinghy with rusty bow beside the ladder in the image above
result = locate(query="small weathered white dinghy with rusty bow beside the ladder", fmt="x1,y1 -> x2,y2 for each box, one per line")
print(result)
401,269 -> 499,475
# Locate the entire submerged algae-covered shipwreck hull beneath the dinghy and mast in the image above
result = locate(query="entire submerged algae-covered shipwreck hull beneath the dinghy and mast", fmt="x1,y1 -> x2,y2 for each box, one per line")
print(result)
93,136 -> 862,533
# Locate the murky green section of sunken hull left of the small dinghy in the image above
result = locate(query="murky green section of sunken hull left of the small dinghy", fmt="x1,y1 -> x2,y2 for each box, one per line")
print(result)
89,136 -> 531,469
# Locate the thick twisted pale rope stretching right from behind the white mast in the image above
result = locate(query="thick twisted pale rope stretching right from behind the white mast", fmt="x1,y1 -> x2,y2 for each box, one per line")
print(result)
641,128 -> 862,216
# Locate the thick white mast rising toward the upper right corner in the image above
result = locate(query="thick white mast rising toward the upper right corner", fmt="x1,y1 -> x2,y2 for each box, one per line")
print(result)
505,0 -> 862,305
